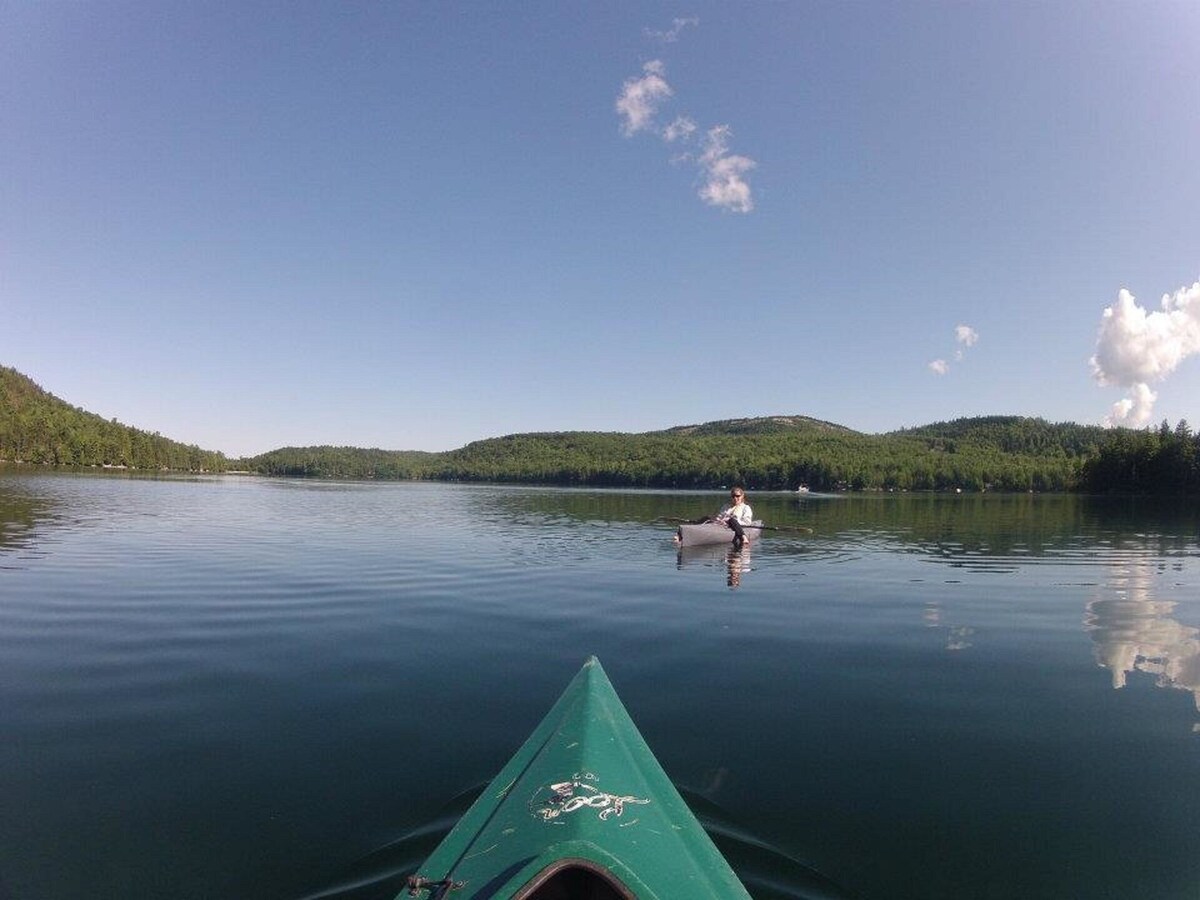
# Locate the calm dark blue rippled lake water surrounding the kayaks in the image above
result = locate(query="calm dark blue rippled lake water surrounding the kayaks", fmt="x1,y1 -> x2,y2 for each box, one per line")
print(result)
0,467 -> 1200,900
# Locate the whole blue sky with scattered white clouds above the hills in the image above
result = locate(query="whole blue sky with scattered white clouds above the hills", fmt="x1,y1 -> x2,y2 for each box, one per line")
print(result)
0,0 -> 1200,456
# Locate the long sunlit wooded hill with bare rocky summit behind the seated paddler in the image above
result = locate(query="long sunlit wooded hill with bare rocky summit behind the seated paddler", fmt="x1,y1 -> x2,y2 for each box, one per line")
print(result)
427,416 -> 1082,491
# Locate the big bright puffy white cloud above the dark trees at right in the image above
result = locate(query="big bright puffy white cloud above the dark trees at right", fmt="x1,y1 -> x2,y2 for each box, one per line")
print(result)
1090,281 -> 1200,427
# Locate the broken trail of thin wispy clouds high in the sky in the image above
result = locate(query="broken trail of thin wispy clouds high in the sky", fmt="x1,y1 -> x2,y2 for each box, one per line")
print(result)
616,26 -> 757,212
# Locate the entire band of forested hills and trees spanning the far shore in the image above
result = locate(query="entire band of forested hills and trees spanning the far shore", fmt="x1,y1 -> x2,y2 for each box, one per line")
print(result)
0,367 -> 1200,494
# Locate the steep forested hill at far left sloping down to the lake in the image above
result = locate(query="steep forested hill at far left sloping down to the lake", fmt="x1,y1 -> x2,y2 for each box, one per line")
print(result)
0,366 -> 228,472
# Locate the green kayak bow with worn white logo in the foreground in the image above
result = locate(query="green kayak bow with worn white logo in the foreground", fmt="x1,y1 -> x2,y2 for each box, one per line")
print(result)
408,656 -> 750,900
